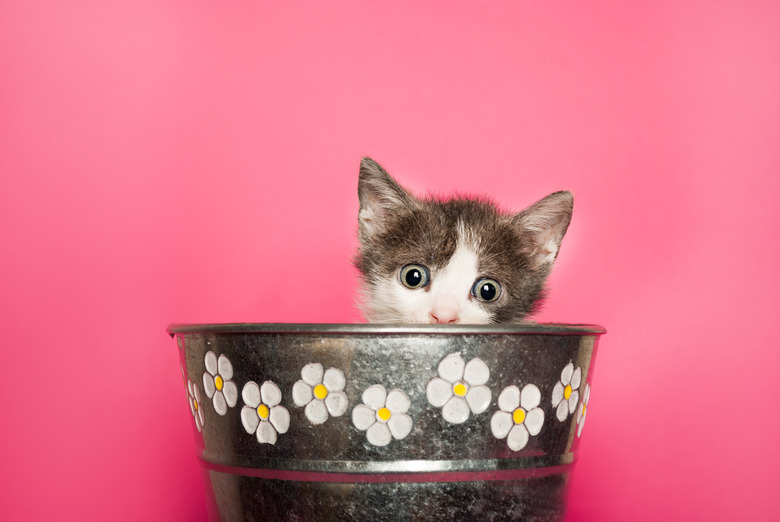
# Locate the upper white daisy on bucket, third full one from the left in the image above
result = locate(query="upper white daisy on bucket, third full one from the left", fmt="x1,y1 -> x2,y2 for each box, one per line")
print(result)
293,363 -> 347,424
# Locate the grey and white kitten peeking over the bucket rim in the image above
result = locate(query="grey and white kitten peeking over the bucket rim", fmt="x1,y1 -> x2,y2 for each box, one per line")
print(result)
354,158 -> 573,324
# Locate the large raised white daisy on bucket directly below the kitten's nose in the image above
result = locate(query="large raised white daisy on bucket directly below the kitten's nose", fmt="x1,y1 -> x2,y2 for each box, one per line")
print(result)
425,353 -> 491,424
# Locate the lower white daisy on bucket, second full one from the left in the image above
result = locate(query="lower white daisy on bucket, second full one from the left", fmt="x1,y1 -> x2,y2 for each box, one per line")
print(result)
241,381 -> 290,444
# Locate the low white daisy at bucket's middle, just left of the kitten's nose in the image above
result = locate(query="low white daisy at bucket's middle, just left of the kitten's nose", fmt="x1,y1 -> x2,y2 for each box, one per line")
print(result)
352,384 -> 412,446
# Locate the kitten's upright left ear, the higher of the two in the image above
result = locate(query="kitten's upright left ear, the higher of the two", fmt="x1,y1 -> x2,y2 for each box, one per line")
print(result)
358,158 -> 416,237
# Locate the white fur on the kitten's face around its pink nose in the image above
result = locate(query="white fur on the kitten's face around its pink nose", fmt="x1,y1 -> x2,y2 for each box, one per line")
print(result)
362,225 -> 492,324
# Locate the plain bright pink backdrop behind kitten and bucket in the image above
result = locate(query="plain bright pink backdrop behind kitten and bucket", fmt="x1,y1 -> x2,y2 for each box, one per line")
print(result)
0,0 -> 780,521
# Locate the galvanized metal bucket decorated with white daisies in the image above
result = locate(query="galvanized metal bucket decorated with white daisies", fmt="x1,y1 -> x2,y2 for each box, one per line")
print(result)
168,324 -> 605,521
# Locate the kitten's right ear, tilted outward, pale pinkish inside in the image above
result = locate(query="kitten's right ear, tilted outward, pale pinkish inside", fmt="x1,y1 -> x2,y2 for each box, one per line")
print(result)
512,191 -> 574,270
